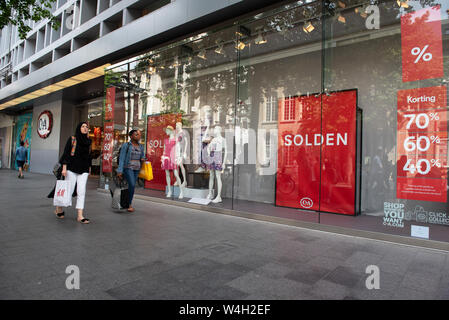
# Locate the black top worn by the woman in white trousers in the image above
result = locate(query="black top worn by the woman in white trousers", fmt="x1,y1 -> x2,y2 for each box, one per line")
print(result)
60,137 -> 92,174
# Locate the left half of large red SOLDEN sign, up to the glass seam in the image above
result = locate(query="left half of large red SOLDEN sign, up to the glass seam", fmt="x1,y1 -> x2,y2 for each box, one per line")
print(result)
276,95 -> 321,210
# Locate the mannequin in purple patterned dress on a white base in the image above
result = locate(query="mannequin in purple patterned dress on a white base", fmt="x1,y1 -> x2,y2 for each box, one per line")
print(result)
207,126 -> 227,203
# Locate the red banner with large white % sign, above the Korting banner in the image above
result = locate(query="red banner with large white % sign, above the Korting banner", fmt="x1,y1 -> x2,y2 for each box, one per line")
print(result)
401,5 -> 444,82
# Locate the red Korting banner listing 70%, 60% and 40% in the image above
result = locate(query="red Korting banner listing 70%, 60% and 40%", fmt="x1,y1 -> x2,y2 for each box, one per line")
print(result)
396,86 -> 448,202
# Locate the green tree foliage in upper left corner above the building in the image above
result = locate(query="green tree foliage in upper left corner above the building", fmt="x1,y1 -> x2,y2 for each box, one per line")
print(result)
0,0 -> 60,39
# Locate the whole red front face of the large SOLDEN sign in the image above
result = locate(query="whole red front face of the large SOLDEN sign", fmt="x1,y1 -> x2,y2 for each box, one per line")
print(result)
276,90 -> 357,215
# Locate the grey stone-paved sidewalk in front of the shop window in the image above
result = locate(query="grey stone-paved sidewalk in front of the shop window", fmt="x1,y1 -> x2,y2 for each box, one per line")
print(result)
0,169 -> 449,299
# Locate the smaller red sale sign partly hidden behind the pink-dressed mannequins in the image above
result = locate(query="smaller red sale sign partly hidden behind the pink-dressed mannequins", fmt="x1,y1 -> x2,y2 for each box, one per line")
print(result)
145,114 -> 181,190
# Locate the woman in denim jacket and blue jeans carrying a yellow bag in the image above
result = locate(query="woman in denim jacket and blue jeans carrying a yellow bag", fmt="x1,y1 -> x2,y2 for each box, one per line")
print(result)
117,130 -> 145,212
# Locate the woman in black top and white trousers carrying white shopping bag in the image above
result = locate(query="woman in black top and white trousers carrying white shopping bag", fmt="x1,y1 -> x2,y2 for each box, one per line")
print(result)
55,122 -> 92,224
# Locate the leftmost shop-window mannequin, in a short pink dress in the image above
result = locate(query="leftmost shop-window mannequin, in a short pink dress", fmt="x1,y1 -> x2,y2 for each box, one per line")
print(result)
161,126 -> 184,199
